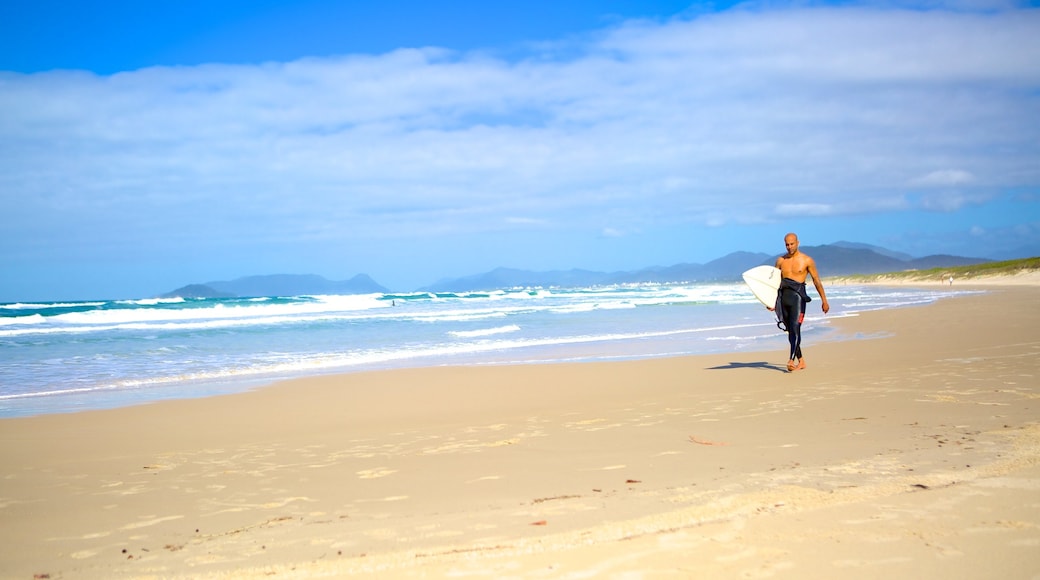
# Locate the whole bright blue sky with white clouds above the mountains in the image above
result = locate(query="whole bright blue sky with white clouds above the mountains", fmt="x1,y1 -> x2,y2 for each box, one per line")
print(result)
0,0 -> 1040,301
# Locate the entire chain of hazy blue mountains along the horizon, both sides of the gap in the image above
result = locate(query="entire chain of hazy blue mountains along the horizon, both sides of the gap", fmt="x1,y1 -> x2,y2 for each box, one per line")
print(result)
163,242 -> 992,298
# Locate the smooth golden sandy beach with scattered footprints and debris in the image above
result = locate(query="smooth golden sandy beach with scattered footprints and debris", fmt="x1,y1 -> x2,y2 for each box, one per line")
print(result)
0,285 -> 1040,579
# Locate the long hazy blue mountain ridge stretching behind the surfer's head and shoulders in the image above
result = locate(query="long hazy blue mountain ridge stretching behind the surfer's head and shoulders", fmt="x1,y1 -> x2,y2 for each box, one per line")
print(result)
419,242 -> 991,292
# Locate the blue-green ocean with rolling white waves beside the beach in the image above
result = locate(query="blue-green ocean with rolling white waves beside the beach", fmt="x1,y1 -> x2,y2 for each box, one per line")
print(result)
0,284 -> 969,418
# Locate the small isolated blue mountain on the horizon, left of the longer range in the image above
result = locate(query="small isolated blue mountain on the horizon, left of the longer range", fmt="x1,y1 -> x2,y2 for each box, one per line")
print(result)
163,274 -> 389,298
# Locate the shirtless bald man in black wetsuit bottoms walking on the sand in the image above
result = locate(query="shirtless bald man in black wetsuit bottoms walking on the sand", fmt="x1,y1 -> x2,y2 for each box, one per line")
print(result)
770,234 -> 831,372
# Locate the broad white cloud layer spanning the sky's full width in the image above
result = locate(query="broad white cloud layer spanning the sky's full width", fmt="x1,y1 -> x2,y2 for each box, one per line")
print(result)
0,3 -> 1040,284
